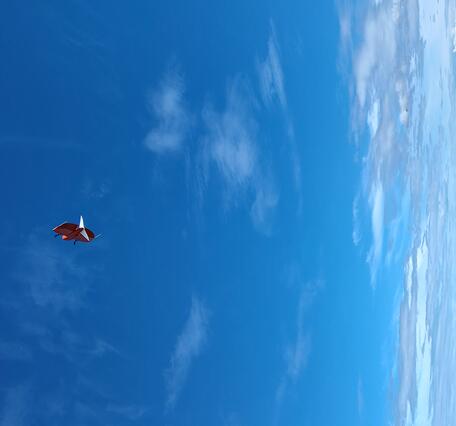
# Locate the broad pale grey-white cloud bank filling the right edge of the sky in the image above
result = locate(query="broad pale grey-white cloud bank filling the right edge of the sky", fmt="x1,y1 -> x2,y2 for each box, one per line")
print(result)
340,0 -> 456,425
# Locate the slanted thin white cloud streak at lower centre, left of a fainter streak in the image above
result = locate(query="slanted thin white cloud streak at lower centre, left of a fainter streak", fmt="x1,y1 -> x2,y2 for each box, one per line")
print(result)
165,297 -> 208,410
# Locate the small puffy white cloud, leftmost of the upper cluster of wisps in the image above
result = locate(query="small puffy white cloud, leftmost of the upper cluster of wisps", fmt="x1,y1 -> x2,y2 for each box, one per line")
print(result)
144,72 -> 190,154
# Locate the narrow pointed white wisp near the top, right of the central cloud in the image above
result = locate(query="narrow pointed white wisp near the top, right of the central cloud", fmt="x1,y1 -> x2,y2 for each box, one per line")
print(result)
259,23 -> 287,109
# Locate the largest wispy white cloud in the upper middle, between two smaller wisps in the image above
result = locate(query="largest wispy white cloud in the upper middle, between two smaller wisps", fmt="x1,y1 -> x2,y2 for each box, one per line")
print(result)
200,77 -> 279,234
